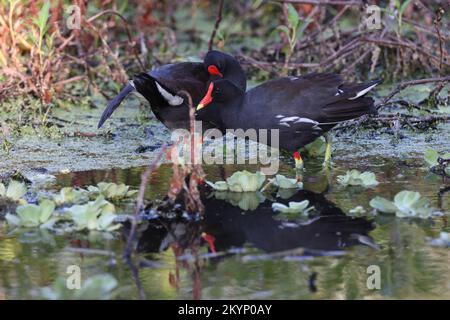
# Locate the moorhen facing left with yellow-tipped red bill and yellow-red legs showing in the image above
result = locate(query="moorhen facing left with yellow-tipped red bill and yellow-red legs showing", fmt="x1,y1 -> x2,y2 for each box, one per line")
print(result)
197,73 -> 380,168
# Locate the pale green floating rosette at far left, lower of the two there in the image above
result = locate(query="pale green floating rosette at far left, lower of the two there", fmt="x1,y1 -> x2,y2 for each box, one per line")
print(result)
5,200 -> 56,228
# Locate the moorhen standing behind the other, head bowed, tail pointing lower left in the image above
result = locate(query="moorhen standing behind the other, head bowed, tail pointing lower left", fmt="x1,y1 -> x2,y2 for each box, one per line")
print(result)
98,50 -> 246,130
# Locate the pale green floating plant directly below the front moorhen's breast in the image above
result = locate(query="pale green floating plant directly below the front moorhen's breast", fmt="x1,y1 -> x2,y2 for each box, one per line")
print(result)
206,170 -> 266,192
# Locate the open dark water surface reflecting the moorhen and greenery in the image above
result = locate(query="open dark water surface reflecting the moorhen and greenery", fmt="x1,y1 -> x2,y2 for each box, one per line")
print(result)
0,151 -> 450,299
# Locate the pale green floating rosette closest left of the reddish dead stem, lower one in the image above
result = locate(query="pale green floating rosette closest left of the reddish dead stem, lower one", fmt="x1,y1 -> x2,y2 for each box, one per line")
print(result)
67,196 -> 121,232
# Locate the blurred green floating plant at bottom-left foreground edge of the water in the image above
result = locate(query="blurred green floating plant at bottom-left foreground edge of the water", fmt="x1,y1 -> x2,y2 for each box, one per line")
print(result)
41,274 -> 118,300
